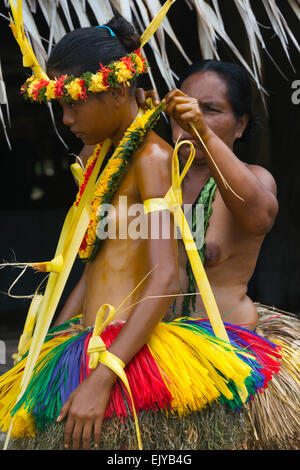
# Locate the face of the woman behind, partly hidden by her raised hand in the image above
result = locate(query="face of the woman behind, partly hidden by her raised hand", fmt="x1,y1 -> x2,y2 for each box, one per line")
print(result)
171,71 -> 248,161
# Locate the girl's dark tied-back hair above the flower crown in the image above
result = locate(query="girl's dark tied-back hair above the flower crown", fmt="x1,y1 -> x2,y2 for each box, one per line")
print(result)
47,15 -> 141,80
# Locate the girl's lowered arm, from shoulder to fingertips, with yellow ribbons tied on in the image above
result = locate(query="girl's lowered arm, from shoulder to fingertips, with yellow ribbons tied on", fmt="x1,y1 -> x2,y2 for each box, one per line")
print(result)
58,139 -> 179,449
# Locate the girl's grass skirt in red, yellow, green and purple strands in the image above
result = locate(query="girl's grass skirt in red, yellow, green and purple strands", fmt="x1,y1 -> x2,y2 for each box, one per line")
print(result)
0,317 -> 281,438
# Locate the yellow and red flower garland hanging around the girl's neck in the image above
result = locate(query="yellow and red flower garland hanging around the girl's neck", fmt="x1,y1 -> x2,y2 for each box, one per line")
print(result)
74,105 -> 162,261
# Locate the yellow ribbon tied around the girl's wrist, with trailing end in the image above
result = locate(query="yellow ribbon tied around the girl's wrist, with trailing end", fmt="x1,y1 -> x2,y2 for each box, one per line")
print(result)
87,304 -> 142,450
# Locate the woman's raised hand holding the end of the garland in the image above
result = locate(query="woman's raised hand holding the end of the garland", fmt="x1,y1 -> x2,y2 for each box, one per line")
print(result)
162,88 -> 210,140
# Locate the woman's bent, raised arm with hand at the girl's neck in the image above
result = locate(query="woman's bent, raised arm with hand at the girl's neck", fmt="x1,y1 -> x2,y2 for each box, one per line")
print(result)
162,89 -> 278,236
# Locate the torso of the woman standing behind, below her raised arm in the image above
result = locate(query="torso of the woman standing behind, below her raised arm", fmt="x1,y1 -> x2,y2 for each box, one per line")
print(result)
175,165 -> 264,329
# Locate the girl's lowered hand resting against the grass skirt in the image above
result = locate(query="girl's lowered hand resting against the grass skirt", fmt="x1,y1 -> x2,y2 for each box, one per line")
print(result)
57,365 -> 116,450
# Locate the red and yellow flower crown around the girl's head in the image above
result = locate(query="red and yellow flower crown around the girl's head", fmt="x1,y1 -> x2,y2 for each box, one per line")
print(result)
21,49 -> 149,102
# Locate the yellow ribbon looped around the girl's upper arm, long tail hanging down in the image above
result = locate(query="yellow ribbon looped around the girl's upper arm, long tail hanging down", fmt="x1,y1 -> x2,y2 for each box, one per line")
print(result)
144,140 -> 248,402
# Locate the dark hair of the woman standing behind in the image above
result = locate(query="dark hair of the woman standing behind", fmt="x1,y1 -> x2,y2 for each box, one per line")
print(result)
178,60 -> 261,141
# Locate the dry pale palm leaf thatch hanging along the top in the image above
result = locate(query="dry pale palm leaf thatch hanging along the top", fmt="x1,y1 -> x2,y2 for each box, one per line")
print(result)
0,0 -> 300,147
